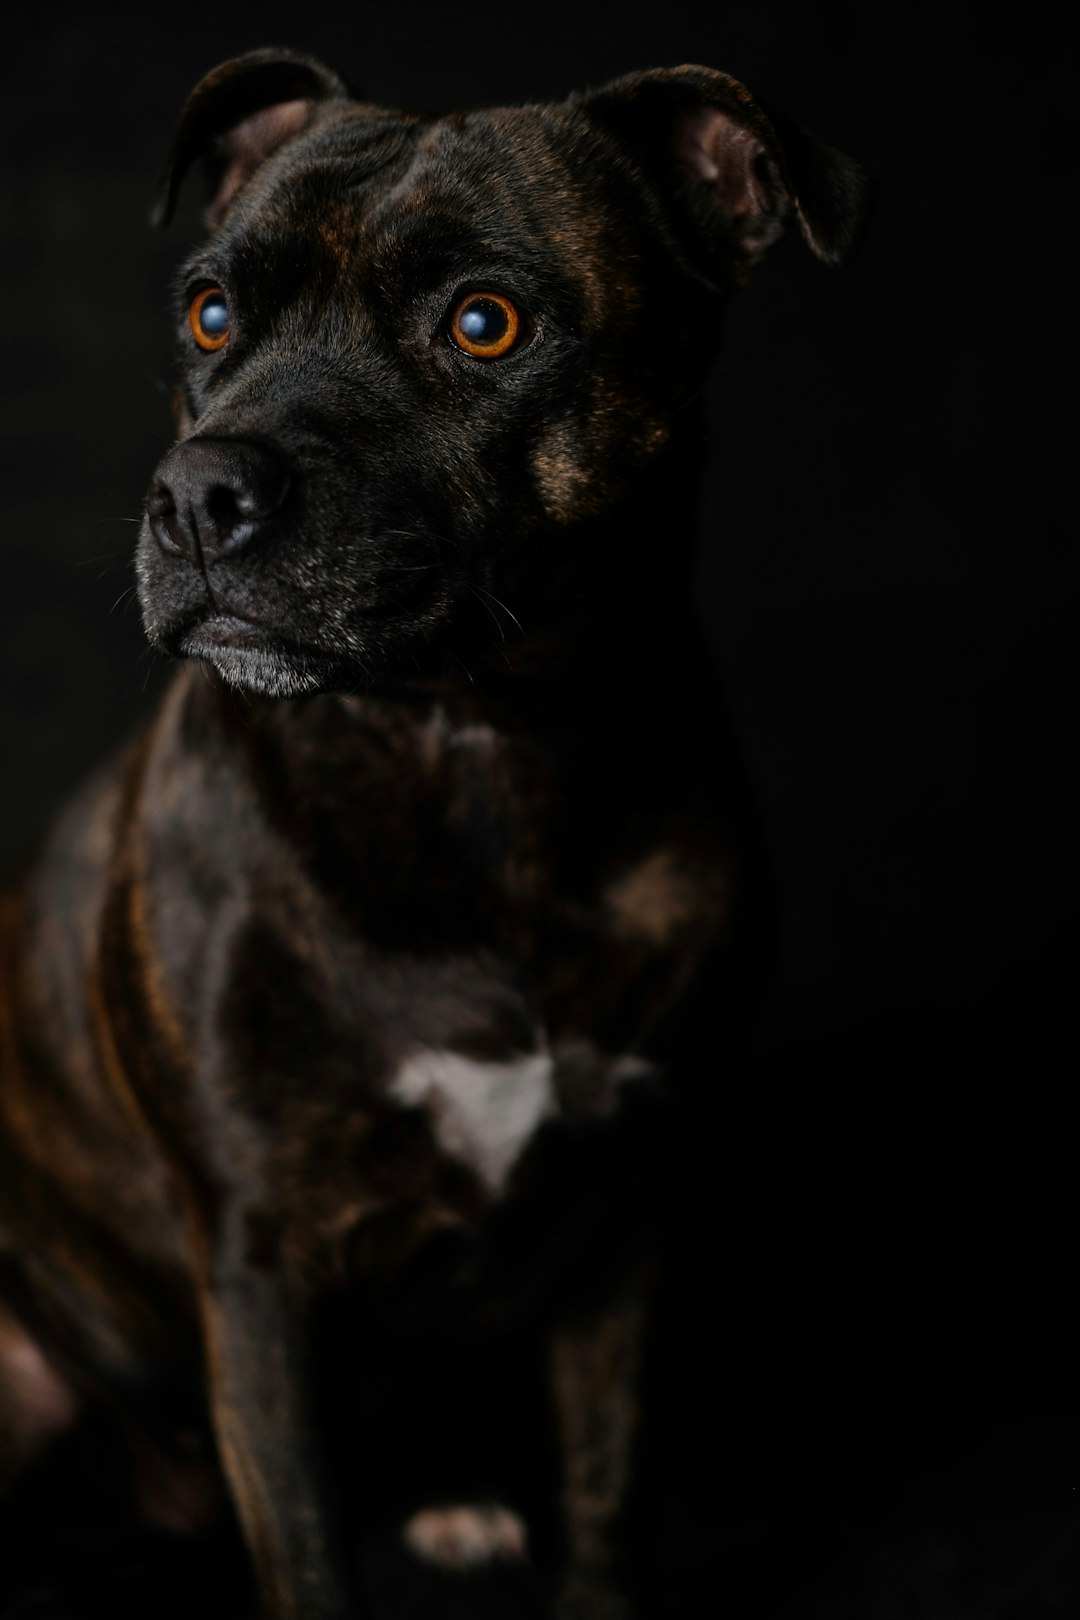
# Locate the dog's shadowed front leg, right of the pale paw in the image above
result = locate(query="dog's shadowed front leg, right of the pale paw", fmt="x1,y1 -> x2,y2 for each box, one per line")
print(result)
552,1283 -> 644,1620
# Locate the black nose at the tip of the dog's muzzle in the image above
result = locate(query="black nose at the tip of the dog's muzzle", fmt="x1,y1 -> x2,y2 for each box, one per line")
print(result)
146,439 -> 288,564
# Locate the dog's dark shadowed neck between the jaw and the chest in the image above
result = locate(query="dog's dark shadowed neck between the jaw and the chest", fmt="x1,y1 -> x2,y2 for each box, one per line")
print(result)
175,495 -> 714,936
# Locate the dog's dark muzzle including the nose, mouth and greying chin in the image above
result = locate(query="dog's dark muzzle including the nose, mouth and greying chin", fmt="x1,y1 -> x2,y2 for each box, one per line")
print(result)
136,434 -> 518,697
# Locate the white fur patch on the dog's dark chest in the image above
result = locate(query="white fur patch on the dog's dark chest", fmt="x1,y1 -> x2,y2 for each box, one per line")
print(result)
390,1048 -> 555,1192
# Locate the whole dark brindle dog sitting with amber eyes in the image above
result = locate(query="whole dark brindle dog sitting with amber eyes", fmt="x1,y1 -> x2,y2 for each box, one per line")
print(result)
0,52 -> 868,1620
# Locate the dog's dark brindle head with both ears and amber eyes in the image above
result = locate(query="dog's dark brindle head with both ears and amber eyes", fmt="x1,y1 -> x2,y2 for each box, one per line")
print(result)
138,52 -> 868,695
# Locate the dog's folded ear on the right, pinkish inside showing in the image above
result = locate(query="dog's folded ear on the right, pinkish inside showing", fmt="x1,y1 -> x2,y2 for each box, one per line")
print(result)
578,66 -> 873,284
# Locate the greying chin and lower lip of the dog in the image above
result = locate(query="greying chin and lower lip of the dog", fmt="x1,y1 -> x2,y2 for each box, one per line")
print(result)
174,617 -> 363,698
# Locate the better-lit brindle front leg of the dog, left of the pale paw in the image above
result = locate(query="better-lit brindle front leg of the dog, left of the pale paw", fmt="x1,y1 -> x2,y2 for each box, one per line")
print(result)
191,1217 -> 348,1620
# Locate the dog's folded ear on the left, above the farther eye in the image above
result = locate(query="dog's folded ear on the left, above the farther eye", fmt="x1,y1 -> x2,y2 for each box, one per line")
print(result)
151,50 -> 348,228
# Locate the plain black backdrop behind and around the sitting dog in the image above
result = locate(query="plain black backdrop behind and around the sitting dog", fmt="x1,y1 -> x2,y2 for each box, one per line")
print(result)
0,0 -> 1080,1620
